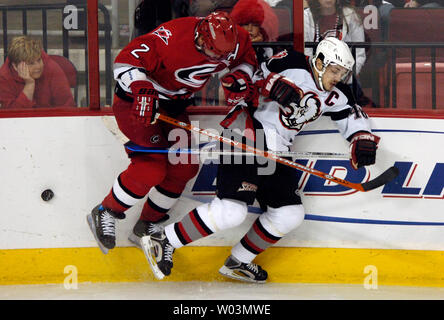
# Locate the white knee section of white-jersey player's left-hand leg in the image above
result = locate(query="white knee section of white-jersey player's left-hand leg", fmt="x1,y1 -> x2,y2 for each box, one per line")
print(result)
197,197 -> 248,232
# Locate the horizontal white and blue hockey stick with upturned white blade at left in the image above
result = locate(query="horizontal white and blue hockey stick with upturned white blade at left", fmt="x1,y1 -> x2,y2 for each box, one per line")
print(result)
102,116 -> 349,159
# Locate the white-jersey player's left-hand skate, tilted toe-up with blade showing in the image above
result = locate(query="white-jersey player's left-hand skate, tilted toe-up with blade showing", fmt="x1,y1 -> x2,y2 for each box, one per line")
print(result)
140,228 -> 174,280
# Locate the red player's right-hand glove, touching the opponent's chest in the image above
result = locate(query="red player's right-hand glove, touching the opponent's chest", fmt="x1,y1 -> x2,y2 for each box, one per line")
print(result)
221,70 -> 254,107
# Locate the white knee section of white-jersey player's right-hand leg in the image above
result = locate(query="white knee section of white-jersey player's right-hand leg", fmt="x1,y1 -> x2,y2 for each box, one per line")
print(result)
259,204 -> 305,237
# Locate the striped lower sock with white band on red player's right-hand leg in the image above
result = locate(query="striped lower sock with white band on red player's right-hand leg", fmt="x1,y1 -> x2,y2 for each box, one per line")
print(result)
140,186 -> 180,222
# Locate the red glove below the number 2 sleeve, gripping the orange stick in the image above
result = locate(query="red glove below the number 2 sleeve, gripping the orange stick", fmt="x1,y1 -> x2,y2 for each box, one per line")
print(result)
130,80 -> 159,126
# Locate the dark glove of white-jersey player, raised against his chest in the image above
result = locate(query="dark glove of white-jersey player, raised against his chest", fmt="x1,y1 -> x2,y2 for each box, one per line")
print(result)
261,72 -> 304,107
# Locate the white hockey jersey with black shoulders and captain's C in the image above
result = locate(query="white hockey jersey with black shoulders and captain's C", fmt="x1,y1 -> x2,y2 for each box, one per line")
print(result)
254,51 -> 371,151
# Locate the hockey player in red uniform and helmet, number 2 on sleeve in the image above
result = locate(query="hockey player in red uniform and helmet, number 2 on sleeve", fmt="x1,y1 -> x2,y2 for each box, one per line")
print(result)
88,12 -> 257,253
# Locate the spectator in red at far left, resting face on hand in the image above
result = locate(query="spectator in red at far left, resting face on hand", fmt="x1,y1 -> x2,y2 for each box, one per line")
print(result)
0,36 -> 75,109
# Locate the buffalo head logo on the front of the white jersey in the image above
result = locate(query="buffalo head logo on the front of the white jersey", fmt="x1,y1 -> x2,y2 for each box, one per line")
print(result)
279,92 -> 321,132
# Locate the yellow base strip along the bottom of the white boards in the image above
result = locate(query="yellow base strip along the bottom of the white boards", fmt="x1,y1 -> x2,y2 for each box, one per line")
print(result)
0,247 -> 444,287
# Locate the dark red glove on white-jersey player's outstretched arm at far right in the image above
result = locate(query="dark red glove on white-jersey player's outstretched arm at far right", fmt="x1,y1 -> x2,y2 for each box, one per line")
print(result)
349,131 -> 381,170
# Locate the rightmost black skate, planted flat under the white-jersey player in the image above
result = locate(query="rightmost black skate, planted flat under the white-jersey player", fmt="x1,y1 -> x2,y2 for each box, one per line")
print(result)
219,256 -> 268,283
